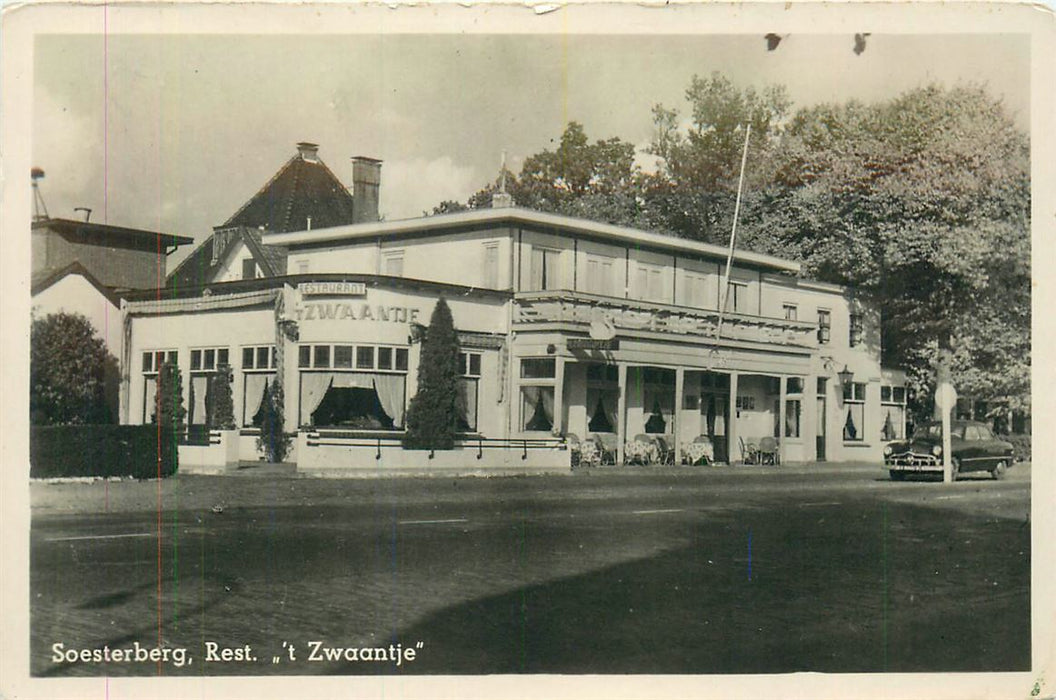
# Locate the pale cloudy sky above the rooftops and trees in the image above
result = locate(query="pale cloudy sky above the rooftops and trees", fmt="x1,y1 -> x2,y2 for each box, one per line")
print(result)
32,34 -> 1031,265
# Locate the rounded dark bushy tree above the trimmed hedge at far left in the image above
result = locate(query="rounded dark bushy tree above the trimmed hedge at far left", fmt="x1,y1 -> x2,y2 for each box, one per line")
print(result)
30,311 -> 117,425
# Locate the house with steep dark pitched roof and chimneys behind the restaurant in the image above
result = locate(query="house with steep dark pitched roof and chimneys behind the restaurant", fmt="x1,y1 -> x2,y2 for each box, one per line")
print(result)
166,141 -> 381,287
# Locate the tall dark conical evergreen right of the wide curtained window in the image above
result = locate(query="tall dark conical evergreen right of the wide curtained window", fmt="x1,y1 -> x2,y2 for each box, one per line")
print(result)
403,297 -> 461,450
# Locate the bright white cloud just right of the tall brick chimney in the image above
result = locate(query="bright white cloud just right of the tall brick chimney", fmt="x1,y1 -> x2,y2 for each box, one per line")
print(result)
380,155 -> 487,220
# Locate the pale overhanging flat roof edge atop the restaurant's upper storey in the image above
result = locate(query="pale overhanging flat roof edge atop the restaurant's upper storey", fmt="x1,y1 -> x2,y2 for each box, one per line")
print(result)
264,207 -> 799,272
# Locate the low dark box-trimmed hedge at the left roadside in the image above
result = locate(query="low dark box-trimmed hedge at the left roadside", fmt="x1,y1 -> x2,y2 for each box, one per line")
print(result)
30,424 -> 177,478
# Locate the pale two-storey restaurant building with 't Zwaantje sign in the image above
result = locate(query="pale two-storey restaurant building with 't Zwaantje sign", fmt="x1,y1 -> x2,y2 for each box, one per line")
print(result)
121,195 -> 906,469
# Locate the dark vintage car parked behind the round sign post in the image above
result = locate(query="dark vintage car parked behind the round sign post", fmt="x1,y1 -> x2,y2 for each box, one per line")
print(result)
884,420 -> 1014,481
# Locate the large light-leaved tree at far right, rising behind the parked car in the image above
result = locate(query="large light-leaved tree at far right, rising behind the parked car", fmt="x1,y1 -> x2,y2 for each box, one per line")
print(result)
760,86 -> 1031,413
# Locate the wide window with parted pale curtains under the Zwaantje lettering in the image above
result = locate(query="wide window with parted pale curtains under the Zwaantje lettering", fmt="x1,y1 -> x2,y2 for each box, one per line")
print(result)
300,372 -> 407,430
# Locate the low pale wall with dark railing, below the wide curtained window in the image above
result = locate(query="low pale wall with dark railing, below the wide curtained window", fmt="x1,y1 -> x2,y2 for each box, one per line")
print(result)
297,432 -> 572,476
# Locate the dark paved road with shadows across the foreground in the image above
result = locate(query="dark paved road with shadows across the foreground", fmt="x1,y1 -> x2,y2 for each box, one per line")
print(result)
31,466 -> 1030,676
